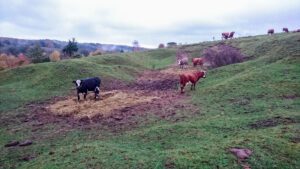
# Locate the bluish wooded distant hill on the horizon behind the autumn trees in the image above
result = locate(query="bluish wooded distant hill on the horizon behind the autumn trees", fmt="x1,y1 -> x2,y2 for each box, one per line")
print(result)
0,37 -> 140,55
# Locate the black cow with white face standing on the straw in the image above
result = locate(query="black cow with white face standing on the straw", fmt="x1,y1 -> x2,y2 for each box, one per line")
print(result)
73,77 -> 101,101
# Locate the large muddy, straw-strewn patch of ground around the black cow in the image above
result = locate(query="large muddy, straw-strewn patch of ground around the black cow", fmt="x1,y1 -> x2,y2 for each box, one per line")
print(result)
20,68 -> 200,131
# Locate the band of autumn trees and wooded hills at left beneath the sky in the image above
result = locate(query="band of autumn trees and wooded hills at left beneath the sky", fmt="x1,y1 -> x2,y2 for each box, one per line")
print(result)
0,38 -> 132,70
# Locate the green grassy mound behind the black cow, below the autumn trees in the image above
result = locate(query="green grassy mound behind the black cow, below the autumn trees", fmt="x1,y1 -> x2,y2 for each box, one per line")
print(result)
0,49 -> 175,112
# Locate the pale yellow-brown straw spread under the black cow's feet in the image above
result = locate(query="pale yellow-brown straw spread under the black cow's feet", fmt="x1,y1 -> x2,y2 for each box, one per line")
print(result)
48,90 -> 158,118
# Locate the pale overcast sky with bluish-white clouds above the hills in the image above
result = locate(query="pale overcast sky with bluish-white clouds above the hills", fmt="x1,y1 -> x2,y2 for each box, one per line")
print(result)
0,0 -> 300,47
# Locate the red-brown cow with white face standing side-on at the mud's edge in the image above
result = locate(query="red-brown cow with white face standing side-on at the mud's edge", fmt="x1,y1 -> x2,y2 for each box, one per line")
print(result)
179,71 -> 206,93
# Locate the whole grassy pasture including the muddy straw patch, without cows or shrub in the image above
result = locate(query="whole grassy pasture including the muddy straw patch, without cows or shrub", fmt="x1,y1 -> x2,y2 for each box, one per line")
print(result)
0,33 -> 300,169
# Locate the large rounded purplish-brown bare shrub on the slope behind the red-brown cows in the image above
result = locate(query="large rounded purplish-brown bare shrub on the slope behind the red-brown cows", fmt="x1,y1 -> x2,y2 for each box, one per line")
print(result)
202,45 -> 244,68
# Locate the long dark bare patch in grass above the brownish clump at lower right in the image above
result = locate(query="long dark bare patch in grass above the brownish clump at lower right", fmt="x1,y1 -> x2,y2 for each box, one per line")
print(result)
249,116 -> 297,129
